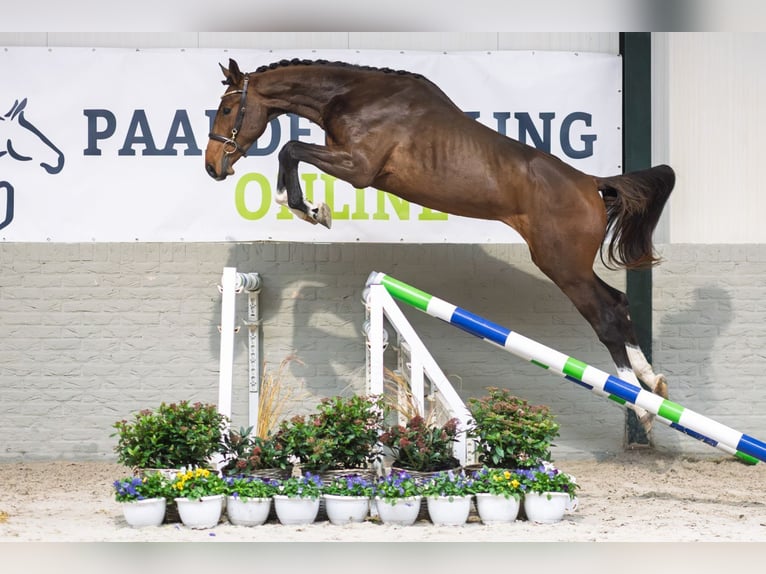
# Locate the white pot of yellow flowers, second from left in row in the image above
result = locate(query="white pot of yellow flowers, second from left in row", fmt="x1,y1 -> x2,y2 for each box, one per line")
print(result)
170,468 -> 226,529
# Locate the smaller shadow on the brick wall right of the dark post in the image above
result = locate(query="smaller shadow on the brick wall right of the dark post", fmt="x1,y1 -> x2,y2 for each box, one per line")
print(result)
654,285 -> 734,452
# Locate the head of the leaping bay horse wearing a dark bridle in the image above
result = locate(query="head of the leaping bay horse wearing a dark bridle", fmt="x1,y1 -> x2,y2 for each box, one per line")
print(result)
205,59 -> 269,181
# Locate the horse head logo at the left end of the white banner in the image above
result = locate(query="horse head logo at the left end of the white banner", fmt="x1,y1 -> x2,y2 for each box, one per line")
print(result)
0,98 -> 64,229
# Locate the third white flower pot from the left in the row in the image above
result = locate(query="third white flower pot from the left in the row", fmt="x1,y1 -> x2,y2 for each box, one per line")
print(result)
224,476 -> 279,526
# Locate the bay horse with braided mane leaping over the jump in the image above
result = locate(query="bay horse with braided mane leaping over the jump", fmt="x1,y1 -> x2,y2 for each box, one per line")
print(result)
205,59 -> 675,430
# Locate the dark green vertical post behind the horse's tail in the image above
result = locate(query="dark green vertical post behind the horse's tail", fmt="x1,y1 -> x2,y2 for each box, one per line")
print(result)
620,32 -> 652,447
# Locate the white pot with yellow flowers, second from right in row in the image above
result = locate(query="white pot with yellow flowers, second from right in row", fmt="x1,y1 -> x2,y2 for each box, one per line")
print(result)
473,466 -> 524,524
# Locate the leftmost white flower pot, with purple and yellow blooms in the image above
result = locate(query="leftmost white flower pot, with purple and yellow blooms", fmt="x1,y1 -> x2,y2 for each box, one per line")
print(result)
112,472 -> 169,528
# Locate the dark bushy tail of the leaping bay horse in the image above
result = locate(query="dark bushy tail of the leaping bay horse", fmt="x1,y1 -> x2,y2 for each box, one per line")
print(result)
596,165 -> 676,269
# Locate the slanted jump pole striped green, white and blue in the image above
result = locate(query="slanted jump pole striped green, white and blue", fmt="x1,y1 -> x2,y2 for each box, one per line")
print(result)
367,271 -> 766,464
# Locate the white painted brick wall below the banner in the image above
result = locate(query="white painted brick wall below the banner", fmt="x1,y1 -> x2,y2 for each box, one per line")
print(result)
0,244 -> 766,461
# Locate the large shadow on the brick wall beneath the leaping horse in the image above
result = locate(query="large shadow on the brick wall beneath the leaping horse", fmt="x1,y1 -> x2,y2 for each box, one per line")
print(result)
210,243 -> 622,432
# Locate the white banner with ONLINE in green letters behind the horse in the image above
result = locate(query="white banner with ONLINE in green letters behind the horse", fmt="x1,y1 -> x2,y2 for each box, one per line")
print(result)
0,47 -> 622,243
